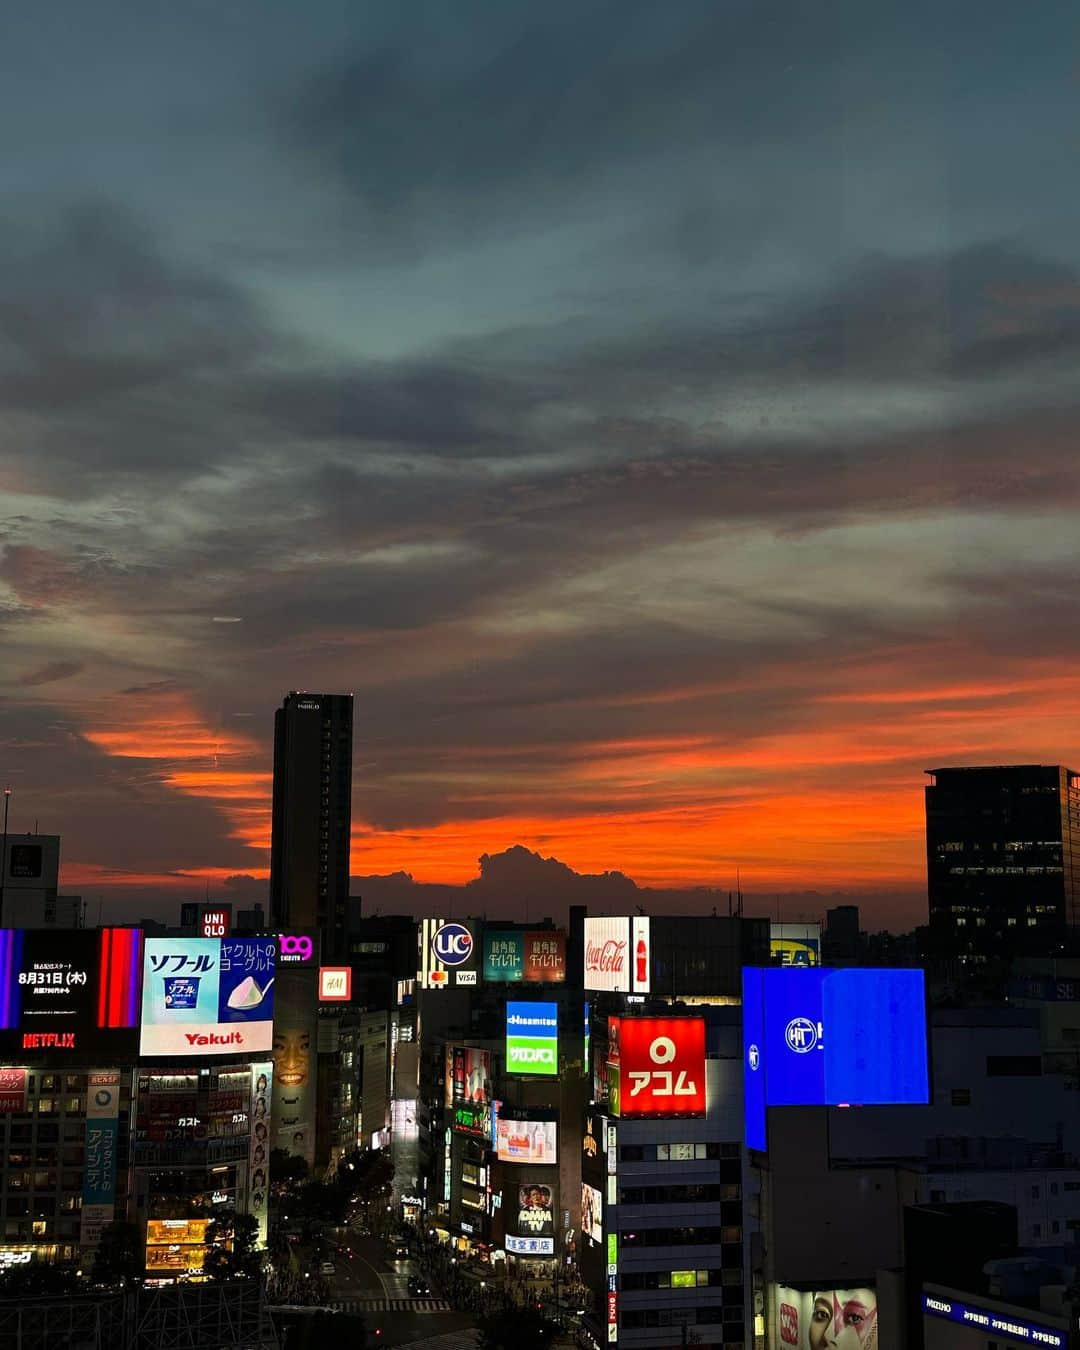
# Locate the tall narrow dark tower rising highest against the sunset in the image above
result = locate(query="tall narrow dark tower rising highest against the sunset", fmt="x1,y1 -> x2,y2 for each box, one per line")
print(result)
270,691 -> 352,956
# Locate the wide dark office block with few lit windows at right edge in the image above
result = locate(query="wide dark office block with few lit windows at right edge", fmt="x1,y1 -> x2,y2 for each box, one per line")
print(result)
926,764 -> 1080,957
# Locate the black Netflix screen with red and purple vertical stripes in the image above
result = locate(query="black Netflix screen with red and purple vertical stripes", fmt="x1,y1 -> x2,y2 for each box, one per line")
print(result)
0,927 -> 142,1060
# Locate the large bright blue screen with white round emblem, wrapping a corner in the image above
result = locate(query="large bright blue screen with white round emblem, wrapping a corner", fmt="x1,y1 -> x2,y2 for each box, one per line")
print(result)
743,967 -> 930,1149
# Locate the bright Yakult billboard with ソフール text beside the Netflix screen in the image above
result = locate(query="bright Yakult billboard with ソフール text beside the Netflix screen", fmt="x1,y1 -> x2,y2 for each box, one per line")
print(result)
139,937 -> 277,1054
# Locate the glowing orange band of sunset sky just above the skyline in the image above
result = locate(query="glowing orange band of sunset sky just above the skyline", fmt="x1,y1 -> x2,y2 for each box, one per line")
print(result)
57,663 -> 1080,892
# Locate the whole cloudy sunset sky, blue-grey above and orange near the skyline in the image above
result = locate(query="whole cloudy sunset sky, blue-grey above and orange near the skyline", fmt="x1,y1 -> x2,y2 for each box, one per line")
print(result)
0,0 -> 1080,922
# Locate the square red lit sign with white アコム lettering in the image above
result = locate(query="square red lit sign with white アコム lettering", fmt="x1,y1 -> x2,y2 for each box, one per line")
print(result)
618,1017 -> 705,1119
